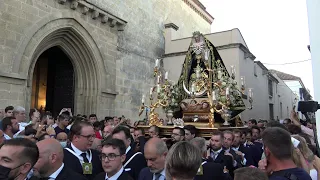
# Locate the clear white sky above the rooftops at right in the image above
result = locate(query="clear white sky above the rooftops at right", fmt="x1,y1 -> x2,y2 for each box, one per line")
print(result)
200,0 -> 313,95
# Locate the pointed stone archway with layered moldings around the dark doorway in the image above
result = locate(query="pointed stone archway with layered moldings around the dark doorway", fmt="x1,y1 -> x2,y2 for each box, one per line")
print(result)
13,18 -> 116,114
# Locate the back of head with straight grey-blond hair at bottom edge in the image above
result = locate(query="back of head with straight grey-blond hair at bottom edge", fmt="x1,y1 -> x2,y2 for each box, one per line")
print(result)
165,141 -> 202,180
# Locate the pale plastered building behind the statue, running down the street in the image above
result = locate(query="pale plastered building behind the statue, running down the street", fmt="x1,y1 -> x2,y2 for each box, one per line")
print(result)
163,23 -> 294,121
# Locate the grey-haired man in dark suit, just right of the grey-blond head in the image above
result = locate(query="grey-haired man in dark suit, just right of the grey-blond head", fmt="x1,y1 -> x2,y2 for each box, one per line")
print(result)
190,137 -> 231,180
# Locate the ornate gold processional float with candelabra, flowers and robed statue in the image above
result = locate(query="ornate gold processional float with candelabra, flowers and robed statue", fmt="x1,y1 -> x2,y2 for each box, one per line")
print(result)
139,32 -> 253,128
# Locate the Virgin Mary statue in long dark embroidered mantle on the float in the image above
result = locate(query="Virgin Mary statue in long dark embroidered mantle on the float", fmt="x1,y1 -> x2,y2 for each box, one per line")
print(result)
175,32 -> 245,122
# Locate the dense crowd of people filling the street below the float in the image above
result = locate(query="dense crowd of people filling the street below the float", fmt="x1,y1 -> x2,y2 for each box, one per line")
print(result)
0,106 -> 320,180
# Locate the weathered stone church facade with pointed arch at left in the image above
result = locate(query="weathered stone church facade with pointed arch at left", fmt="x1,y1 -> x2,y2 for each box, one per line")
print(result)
0,0 -> 213,119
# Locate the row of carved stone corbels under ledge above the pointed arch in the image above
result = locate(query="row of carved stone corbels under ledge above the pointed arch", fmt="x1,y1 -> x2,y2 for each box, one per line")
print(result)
61,0 -> 127,31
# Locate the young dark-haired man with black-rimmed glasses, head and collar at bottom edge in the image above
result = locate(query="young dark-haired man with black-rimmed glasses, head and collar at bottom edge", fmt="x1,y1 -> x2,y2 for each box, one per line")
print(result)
94,139 -> 133,180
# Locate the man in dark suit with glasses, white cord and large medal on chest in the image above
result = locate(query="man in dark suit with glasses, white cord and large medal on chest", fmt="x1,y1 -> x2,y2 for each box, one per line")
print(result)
63,121 -> 103,180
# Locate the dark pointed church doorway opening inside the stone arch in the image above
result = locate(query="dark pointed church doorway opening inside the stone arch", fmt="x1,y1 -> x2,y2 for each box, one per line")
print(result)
31,47 -> 75,116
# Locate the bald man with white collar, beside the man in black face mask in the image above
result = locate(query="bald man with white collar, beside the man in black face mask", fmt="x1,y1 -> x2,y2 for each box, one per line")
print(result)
33,138 -> 86,180
